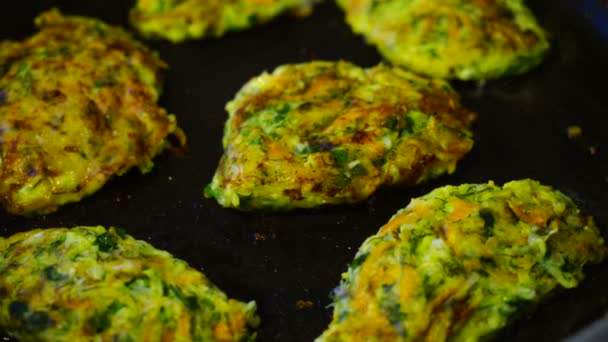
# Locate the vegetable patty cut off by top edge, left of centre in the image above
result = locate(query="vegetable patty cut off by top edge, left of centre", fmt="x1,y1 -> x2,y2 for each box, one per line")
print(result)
131,0 -> 315,43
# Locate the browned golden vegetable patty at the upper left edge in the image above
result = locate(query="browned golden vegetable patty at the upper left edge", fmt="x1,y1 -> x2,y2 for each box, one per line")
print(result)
0,10 -> 184,214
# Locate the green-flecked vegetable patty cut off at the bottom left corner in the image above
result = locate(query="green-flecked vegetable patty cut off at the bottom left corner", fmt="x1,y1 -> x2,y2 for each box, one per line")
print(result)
0,227 -> 258,342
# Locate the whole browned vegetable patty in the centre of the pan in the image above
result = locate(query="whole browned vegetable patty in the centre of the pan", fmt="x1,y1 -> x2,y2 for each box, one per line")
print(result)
205,62 -> 475,210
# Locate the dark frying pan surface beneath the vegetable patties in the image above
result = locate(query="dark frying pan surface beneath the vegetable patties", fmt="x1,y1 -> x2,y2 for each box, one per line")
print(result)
0,0 -> 608,341
